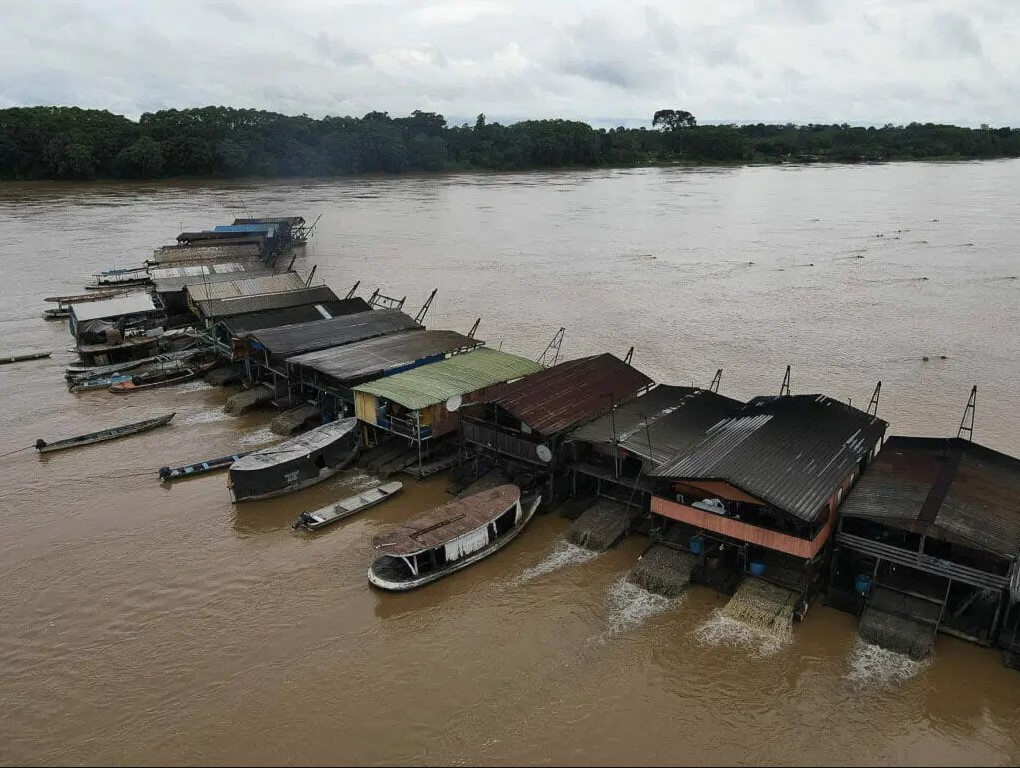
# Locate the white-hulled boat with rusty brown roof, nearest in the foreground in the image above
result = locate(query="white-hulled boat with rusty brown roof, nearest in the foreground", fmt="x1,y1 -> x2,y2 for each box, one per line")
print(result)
368,484 -> 542,592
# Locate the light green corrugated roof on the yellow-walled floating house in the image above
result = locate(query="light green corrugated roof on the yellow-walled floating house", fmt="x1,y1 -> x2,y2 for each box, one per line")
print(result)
354,347 -> 543,411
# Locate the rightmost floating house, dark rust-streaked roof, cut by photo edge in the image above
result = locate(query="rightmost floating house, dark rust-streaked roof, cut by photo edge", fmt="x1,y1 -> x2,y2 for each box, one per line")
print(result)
827,436 -> 1020,664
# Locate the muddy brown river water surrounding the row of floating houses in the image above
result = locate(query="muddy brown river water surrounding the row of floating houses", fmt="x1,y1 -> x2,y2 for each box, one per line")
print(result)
0,161 -> 1020,765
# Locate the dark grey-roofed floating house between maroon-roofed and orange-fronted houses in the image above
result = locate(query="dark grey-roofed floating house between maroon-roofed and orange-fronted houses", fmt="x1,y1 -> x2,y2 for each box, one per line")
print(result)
568,385 -> 744,511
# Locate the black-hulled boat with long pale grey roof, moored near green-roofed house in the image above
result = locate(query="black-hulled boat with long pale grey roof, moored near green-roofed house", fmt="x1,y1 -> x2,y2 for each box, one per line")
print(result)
227,417 -> 360,503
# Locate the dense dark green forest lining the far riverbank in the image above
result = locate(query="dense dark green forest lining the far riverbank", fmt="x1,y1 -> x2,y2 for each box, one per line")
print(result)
0,107 -> 1020,180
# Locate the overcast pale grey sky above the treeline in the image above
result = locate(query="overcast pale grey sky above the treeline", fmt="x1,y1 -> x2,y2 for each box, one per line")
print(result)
0,0 -> 1020,125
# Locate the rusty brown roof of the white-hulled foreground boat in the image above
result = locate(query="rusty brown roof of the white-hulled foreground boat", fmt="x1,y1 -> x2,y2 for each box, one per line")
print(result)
372,485 -> 520,557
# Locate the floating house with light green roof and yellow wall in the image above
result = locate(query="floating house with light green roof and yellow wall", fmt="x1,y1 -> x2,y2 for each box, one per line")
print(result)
354,348 -> 542,471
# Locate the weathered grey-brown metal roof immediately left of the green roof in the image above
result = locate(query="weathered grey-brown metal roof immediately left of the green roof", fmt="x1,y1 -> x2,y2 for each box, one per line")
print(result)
287,328 -> 481,385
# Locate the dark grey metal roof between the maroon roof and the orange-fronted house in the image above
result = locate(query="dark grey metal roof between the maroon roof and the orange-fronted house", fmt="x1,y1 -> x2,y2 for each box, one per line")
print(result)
570,385 -> 744,464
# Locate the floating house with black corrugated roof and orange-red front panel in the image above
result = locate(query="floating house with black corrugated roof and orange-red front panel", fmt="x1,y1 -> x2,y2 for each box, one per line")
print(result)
651,395 -> 886,614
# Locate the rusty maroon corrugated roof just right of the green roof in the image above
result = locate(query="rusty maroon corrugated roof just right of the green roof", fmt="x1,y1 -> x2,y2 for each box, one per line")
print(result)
487,353 -> 652,436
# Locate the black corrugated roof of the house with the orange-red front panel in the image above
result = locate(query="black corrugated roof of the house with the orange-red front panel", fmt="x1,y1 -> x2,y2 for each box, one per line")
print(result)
652,395 -> 887,522
